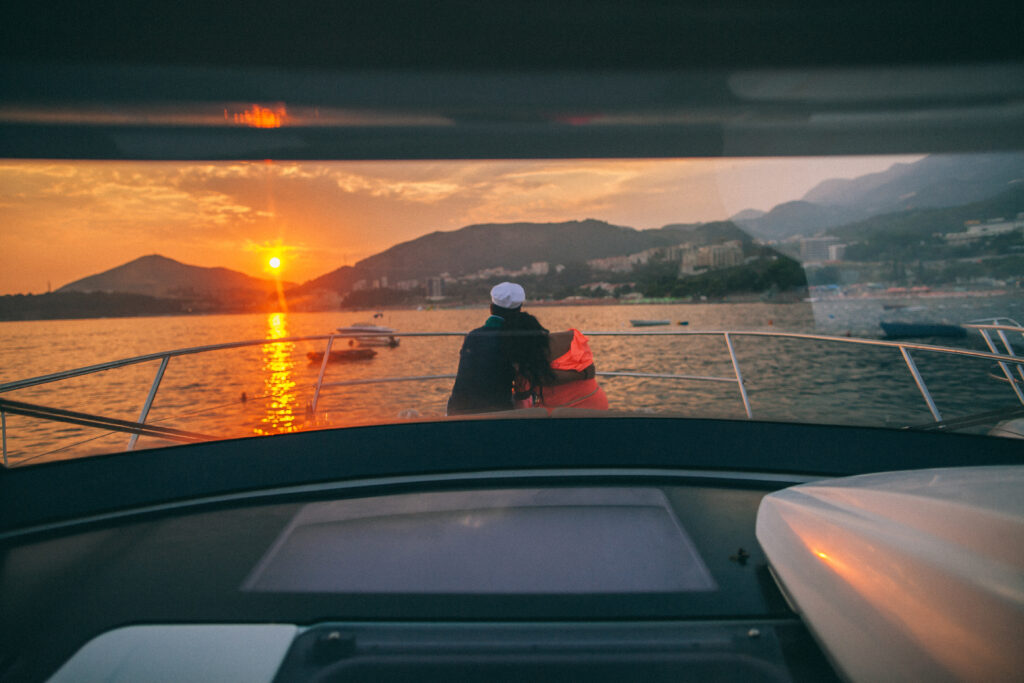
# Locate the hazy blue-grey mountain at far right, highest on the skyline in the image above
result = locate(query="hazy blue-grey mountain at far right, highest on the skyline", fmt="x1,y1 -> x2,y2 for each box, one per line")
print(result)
732,153 -> 1024,240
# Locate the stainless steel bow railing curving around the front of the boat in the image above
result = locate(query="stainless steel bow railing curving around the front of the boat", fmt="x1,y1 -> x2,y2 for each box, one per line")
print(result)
0,325 -> 1024,465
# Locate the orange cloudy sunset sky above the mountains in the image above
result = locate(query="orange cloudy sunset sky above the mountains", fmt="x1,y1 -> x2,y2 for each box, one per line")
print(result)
0,156 -> 922,295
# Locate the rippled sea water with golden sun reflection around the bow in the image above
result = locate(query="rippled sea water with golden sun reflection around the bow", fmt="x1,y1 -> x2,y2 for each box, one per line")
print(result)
0,296 -> 1024,464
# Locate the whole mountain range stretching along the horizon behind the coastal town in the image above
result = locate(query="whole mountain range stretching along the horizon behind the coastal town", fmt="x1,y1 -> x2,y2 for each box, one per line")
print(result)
51,153 -> 1024,301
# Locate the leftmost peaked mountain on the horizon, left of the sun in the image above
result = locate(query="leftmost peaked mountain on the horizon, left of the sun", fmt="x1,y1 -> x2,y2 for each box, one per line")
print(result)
56,254 -> 292,299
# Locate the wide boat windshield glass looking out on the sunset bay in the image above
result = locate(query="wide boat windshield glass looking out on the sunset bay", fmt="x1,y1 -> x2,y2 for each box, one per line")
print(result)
0,154 -> 1024,466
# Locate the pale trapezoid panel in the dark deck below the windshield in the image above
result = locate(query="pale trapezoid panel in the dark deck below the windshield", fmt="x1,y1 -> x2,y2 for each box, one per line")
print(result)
243,488 -> 716,594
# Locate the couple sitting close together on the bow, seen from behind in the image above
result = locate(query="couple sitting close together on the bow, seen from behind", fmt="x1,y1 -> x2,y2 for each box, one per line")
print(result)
447,283 -> 608,415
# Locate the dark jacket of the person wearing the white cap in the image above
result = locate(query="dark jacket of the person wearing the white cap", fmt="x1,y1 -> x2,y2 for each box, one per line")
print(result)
447,315 -> 514,415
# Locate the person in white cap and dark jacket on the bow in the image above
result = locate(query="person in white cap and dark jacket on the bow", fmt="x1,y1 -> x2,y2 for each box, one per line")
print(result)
447,283 -> 526,415
